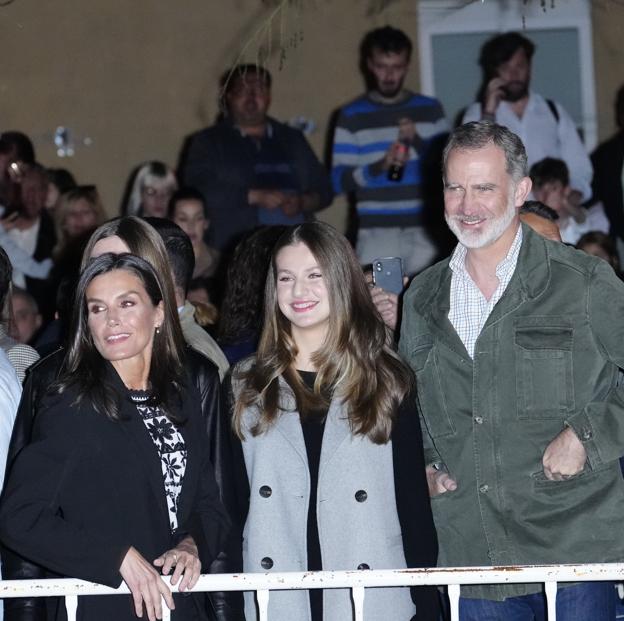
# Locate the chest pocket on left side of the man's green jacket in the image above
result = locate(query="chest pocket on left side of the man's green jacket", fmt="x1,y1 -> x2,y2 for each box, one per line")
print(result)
410,343 -> 455,439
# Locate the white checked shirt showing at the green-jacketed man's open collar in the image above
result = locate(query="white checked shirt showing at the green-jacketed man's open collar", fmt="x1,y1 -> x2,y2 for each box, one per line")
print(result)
448,226 -> 522,358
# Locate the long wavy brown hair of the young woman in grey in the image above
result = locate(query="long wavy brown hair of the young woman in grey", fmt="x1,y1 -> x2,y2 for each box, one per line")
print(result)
233,222 -> 412,444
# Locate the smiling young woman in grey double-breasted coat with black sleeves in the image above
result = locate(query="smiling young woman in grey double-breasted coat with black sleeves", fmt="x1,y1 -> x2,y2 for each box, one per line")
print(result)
232,222 -> 437,621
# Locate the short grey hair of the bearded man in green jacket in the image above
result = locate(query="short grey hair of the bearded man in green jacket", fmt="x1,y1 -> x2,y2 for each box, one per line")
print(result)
442,121 -> 528,183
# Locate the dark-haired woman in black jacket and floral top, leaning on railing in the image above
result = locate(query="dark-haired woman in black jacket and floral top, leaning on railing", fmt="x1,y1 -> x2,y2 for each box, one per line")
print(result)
0,253 -> 228,621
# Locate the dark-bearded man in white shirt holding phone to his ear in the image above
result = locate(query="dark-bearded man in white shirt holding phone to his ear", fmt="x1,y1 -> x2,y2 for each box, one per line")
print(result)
463,32 -> 593,204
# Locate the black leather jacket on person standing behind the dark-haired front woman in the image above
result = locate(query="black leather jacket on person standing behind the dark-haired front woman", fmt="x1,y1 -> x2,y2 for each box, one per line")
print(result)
2,347 -> 244,621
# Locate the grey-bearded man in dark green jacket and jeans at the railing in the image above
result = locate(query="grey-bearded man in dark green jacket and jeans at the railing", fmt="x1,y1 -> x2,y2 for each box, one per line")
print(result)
400,121 -> 624,621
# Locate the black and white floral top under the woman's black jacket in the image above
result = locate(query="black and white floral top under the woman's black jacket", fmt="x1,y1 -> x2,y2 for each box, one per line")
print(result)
130,390 -> 186,531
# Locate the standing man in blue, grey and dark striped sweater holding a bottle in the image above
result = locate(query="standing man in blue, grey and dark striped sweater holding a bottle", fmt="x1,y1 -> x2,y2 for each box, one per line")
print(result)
332,26 -> 448,274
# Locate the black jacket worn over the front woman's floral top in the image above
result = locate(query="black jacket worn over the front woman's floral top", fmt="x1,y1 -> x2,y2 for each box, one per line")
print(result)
0,365 -> 229,621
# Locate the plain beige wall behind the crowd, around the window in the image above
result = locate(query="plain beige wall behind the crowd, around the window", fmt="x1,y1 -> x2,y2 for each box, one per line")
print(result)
0,0 -> 624,226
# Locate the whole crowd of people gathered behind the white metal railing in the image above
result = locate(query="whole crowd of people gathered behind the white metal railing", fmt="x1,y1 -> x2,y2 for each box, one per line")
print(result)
0,21 -> 624,621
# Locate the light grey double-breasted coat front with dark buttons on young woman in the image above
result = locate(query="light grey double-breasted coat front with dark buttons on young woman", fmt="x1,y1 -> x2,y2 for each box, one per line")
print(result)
233,378 -> 415,621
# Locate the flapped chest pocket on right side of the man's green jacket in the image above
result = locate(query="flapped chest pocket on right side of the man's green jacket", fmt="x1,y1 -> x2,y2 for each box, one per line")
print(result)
514,326 -> 574,419
